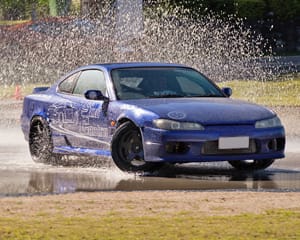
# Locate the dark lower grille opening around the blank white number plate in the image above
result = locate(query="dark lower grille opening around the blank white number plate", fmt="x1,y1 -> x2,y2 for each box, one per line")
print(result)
201,139 -> 257,155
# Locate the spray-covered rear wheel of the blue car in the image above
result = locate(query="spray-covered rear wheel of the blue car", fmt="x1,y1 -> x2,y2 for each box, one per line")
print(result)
29,117 -> 60,164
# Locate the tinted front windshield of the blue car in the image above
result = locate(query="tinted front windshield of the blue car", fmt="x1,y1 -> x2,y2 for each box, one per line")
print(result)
111,67 -> 224,100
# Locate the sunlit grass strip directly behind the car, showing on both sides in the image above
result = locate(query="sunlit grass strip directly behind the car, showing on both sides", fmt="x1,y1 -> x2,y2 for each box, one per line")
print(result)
0,78 -> 300,106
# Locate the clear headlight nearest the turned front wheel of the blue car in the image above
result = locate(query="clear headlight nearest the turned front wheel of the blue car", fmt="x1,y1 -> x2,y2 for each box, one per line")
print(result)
153,119 -> 204,130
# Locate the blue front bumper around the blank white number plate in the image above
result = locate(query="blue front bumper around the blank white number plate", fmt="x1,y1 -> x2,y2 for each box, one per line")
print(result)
143,125 -> 285,163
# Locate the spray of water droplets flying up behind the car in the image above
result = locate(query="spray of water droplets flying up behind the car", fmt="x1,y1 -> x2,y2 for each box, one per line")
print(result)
0,1 -> 292,85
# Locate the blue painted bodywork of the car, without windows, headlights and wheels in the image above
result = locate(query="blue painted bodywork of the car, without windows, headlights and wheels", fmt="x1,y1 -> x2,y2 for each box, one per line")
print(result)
21,63 -> 285,167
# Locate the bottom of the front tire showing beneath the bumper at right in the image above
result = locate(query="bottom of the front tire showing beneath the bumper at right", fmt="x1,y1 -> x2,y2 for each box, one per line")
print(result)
228,159 -> 274,171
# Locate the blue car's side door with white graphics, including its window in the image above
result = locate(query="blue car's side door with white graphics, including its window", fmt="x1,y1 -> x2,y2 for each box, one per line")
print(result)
70,69 -> 109,149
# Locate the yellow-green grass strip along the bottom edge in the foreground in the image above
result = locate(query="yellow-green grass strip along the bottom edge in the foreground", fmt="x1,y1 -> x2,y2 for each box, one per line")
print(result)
0,210 -> 300,240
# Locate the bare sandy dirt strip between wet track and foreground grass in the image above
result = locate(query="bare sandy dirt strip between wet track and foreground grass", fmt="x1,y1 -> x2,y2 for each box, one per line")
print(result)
0,191 -> 300,217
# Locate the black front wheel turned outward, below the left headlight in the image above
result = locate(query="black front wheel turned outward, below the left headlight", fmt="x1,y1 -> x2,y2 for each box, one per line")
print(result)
111,121 -> 160,172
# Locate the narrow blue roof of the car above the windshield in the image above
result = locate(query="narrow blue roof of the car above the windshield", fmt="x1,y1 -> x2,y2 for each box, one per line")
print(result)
79,62 -> 187,71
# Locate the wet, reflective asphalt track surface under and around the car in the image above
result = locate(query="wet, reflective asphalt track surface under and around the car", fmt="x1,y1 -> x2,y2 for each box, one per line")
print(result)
0,127 -> 300,197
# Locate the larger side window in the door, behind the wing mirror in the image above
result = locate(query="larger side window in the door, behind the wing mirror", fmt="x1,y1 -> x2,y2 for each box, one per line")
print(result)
73,70 -> 106,95
